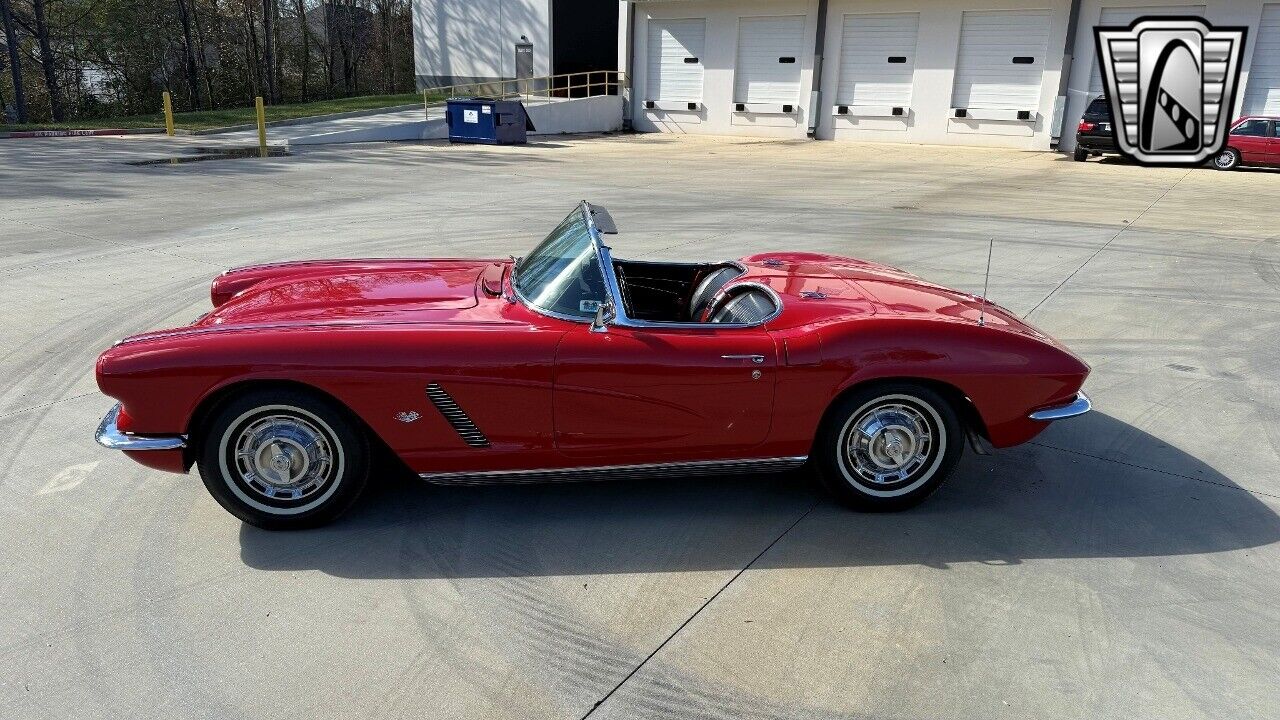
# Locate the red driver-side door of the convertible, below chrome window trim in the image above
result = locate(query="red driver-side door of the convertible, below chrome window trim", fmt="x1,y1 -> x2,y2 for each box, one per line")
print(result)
552,325 -> 778,456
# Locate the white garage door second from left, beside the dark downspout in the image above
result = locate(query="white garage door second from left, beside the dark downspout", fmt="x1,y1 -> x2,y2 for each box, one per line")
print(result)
733,15 -> 804,105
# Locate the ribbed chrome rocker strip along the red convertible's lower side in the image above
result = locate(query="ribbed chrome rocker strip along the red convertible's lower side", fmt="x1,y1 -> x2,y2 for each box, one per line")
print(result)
420,455 -> 809,486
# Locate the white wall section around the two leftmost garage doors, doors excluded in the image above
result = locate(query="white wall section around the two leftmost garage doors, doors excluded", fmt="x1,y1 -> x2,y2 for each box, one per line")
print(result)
630,0 -> 818,137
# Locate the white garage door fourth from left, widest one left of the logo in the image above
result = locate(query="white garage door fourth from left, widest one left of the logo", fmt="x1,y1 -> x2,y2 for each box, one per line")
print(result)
951,10 -> 1050,110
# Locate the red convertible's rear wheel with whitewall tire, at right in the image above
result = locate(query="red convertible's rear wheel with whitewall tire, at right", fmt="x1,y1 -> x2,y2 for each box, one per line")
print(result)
814,383 -> 964,512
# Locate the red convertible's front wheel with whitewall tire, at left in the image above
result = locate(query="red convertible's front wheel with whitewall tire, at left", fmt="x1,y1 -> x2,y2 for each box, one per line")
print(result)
197,388 -> 369,530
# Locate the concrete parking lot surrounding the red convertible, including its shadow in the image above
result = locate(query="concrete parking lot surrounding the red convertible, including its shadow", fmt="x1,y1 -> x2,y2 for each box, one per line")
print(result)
0,135 -> 1280,720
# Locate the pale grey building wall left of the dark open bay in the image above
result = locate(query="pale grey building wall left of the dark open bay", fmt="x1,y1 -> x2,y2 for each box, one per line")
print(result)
413,0 -> 552,88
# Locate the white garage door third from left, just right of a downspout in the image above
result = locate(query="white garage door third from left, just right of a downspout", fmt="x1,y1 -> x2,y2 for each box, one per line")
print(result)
836,13 -> 920,106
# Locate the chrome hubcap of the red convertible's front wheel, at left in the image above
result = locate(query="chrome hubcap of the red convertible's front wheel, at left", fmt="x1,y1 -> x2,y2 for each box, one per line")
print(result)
234,415 -> 334,501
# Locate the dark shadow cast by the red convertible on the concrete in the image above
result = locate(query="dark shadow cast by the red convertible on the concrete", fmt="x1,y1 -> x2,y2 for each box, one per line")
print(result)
241,413 -> 1280,579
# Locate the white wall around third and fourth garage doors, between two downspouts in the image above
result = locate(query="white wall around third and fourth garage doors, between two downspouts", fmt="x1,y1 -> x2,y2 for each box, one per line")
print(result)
817,0 -> 1070,150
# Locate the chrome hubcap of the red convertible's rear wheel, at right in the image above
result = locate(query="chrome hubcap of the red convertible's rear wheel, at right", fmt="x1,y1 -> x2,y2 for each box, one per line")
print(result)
845,402 -> 933,486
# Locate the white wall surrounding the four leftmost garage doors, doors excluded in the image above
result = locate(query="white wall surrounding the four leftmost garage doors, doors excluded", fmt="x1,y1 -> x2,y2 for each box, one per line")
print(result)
631,0 -> 1070,150
